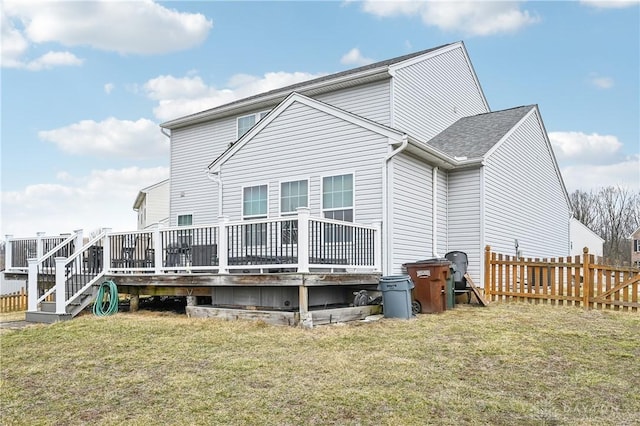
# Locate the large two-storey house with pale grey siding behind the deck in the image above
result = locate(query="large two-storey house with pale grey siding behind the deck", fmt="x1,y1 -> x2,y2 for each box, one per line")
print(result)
161,42 -> 570,283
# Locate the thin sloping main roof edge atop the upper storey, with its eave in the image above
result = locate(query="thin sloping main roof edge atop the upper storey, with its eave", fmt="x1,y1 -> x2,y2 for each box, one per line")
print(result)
160,41 -> 466,129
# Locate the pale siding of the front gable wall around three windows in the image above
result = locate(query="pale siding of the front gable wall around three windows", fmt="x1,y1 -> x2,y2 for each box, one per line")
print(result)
221,102 -> 388,224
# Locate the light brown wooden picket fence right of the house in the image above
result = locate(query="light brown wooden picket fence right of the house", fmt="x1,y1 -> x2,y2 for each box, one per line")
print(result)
484,246 -> 640,312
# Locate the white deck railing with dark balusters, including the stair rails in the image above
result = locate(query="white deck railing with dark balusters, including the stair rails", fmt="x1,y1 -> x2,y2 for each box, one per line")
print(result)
16,208 -> 381,313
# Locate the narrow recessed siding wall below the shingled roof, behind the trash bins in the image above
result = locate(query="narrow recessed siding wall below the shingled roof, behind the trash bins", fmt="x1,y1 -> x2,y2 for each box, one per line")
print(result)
447,168 -> 482,285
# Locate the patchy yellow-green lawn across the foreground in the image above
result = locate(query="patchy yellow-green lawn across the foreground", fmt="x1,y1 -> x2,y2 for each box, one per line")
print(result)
0,304 -> 640,425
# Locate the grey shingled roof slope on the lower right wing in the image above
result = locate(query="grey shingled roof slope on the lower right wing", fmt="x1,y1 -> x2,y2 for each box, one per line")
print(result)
427,105 -> 535,158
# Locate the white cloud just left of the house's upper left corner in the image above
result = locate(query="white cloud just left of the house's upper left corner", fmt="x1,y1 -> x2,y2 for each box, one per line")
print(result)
38,117 -> 169,159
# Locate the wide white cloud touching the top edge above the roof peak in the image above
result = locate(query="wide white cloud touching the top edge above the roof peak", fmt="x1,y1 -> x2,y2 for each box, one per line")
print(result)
362,0 -> 540,36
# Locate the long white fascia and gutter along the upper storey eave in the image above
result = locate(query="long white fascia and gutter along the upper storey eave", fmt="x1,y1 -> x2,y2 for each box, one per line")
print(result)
160,66 -> 389,129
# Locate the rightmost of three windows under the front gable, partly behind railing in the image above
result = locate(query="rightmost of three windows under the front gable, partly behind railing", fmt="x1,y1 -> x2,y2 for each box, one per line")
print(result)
322,174 -> 353,242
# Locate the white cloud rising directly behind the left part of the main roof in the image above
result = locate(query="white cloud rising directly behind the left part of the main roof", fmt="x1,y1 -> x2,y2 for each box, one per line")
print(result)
144,72 -> 322,121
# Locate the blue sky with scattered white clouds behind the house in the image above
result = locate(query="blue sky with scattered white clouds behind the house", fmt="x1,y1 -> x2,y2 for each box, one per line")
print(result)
0,0 -> 640,237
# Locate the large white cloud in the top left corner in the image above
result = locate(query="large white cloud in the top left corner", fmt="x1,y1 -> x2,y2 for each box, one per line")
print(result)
2,0 -> 213,69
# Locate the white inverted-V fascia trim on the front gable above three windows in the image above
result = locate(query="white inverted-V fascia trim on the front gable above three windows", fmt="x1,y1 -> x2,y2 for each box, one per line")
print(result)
208,92 -> 404,173
